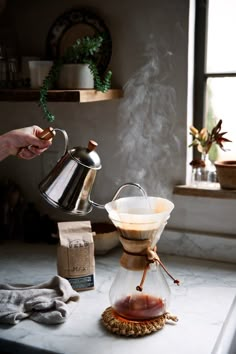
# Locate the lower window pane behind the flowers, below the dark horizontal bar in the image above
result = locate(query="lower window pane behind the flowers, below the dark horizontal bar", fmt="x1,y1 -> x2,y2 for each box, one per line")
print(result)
206,77 -> 236,160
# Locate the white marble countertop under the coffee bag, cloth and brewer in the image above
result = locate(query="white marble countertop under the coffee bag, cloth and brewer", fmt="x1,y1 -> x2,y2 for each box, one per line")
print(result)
0,243 -> 236,354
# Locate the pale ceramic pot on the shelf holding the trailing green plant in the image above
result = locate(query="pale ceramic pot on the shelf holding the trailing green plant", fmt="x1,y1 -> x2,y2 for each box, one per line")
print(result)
58,64 -> 94,89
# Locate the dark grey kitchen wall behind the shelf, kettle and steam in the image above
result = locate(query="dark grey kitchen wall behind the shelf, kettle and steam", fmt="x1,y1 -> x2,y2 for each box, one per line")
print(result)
0,0 -> 236,260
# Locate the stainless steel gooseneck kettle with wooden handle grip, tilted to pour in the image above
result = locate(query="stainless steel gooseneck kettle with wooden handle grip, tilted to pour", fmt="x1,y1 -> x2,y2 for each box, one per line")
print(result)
39,128 -> 145,216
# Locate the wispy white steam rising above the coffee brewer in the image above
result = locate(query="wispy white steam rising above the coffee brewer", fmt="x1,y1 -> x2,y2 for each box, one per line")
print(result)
115,37 -> 178,197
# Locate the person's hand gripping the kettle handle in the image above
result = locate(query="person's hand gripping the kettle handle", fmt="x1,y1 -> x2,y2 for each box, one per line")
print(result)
0,125 -> 52,160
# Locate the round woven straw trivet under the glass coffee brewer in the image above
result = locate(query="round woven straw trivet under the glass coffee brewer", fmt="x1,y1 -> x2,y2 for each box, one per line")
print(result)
102,307 -> 178,337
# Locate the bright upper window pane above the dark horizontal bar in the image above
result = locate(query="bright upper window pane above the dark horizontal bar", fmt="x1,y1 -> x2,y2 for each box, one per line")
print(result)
206,0 -> 236,73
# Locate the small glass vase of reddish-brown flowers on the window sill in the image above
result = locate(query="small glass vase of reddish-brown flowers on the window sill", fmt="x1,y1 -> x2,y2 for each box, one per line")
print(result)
189,119 -> 231,187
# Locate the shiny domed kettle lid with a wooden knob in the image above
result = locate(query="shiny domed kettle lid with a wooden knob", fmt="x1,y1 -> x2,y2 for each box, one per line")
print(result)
70,140 -> 102,170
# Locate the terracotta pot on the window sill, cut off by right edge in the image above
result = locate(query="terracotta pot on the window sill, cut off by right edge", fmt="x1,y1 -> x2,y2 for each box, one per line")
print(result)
215,160 -> 236,189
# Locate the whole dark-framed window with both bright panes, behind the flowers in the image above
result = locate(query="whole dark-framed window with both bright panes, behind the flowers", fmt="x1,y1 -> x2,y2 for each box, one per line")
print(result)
194,0 -> 236,160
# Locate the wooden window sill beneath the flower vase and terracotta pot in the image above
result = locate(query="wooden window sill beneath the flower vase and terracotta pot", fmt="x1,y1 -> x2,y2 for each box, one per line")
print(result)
173,183 -> 236,199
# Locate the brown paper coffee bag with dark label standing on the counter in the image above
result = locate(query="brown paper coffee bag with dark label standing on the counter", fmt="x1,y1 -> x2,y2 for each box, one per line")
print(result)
57,221 -> 95,291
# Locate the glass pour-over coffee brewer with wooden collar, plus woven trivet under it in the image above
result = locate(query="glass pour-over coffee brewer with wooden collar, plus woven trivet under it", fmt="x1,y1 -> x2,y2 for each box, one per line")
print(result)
102,196 -> 179,337
